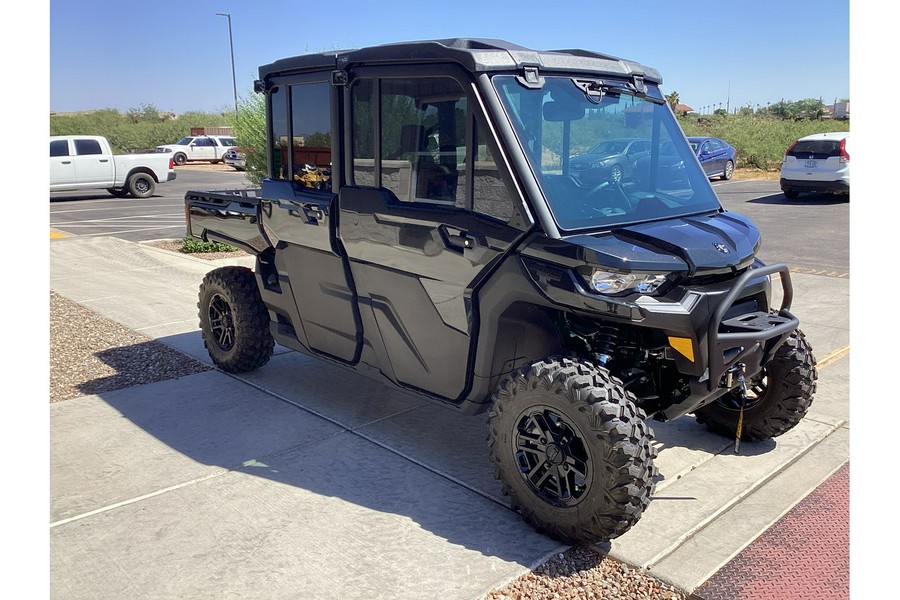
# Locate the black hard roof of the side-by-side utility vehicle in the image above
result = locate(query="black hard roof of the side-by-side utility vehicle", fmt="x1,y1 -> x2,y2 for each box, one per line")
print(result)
259,38 -> 662,84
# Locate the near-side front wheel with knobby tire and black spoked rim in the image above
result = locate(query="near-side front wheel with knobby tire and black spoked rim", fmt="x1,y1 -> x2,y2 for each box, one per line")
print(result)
488,358 -> 658,545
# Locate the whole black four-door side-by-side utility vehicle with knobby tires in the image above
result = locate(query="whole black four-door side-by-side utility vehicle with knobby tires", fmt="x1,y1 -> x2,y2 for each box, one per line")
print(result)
185,39 -> 816,543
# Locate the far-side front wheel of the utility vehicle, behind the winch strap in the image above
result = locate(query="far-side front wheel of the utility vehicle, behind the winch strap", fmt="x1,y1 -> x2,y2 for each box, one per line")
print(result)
696,329 -> 818,442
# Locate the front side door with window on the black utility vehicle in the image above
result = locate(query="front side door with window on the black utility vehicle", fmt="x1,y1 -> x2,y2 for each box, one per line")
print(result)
339,69 -> 522,400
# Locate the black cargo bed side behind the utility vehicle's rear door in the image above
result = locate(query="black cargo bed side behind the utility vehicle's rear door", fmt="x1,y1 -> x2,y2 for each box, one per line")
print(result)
184,189 -> 271,254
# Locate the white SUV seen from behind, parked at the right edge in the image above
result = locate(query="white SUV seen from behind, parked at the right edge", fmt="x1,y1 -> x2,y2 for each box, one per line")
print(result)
780,131 -> 850,199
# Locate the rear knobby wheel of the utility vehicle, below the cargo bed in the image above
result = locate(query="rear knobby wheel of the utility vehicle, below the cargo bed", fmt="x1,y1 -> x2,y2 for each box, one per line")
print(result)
197,267 -> 275,373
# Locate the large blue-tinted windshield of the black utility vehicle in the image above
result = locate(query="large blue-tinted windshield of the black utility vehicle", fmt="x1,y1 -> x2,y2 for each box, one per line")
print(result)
493,75 -> 720,230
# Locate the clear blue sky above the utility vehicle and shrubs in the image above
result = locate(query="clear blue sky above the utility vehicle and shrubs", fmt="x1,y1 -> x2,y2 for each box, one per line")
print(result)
49,0 -> 859,113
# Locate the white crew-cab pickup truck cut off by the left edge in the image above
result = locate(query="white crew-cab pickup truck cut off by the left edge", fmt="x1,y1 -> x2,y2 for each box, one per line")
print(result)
50,135 -> 175,198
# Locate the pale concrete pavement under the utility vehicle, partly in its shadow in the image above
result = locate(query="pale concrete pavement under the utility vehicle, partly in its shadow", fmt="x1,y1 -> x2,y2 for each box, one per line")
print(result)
50,237 -> 849,599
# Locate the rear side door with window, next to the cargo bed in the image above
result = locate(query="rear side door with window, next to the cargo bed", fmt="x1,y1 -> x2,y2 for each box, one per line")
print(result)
262,79 -> 362,364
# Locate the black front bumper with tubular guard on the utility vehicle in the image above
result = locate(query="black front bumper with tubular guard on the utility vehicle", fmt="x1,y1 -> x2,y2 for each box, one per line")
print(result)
524,259 -> 800,420
